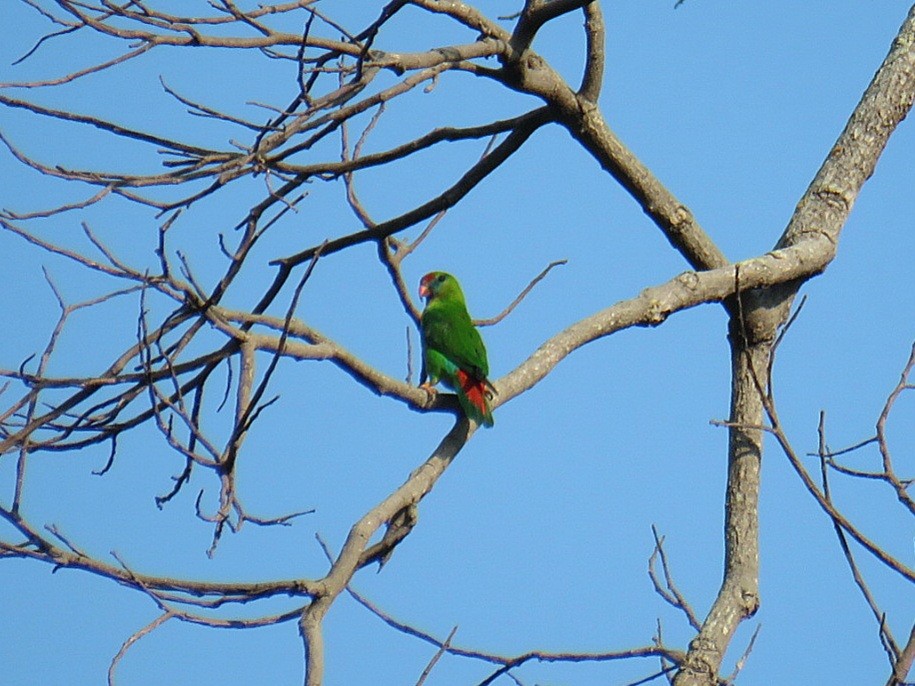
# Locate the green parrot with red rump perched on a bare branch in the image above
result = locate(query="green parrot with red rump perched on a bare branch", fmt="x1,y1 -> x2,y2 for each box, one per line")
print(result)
419,272 -> 495,426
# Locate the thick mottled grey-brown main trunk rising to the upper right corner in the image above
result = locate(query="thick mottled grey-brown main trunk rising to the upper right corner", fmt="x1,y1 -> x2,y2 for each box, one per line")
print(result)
674,6 -> 915,686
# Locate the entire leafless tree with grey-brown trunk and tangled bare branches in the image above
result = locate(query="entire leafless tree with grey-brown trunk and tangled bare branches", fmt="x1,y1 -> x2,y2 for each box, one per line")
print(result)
0,0 -> 915,686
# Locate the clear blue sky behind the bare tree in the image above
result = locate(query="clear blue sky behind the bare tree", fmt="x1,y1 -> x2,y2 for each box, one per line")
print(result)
0,0 -> 915,686
